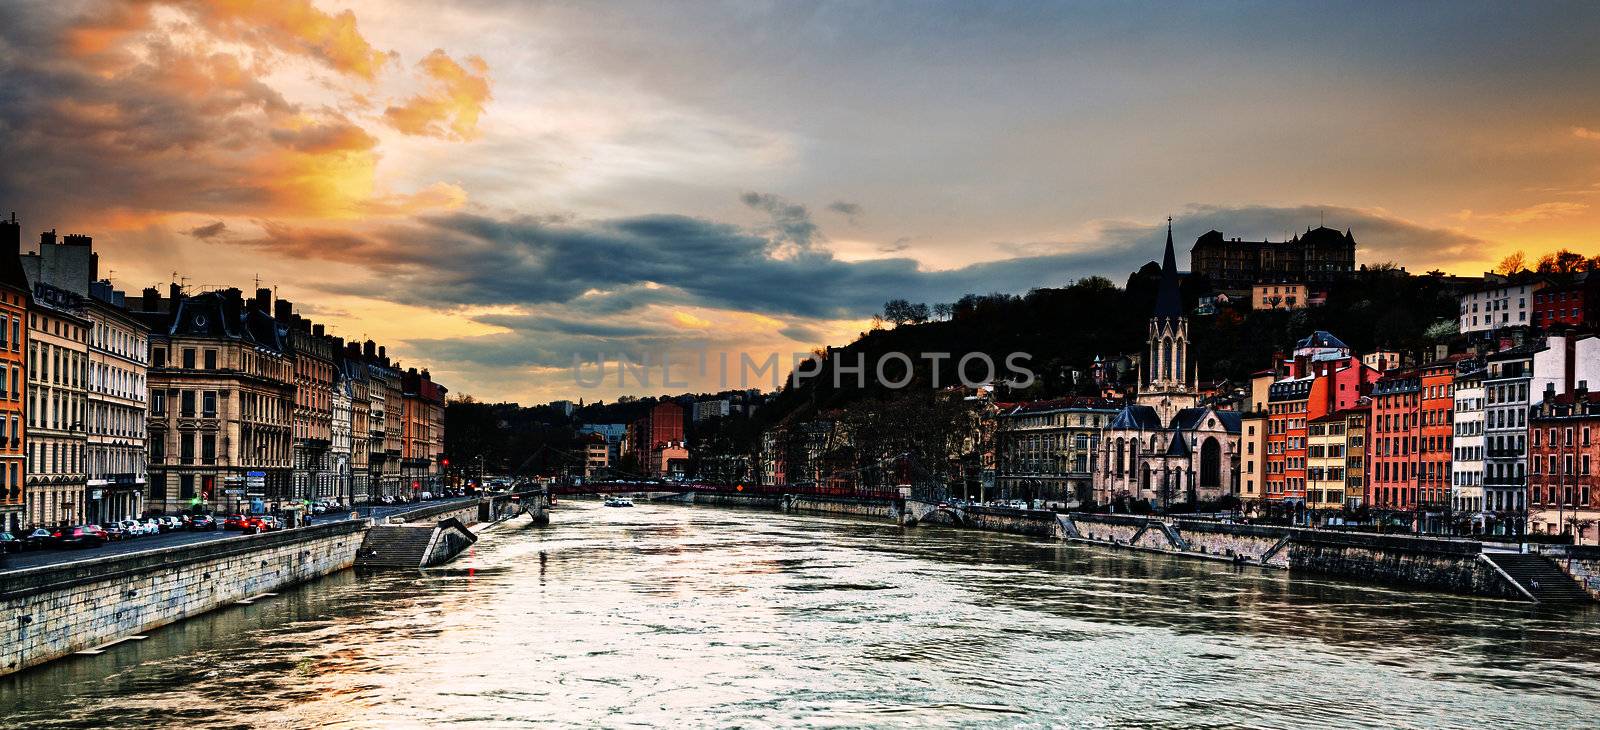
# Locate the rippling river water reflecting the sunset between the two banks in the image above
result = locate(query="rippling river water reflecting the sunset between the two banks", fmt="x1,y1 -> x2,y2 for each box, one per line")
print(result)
0,501 -> 1600,728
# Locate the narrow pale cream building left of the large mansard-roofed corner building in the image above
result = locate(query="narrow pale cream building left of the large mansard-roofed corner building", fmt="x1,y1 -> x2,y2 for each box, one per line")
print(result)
85,280 -> 150,522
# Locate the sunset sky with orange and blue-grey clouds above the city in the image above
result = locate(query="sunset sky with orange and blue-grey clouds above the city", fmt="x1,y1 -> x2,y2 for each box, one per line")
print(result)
0,0 -> 1600,403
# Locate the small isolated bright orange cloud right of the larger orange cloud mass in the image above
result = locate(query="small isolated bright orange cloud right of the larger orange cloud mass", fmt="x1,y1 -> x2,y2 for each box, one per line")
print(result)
384,48 -> 490,139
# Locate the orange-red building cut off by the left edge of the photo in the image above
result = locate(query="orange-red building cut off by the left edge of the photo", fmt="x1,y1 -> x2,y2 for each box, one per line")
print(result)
0,213 -> 29,533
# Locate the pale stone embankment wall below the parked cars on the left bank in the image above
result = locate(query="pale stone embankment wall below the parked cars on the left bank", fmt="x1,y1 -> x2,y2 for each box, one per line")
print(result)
0,520 -> 366,674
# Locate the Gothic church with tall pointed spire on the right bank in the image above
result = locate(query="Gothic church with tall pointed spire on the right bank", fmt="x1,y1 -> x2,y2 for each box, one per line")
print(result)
1093,219 -> 1240,509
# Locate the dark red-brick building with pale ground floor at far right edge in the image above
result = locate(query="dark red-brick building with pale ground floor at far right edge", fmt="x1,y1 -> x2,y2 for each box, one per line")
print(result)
1528,381 -> 1600,544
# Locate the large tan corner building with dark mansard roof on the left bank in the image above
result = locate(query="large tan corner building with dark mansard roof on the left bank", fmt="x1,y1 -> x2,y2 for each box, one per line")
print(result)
134,283 -> 294,512
